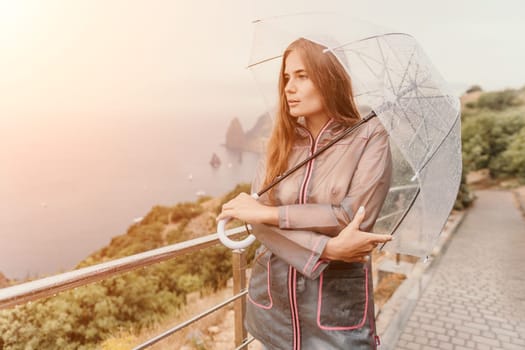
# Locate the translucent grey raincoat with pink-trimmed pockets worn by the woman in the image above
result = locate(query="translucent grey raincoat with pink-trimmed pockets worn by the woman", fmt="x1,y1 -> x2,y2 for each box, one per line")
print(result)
246,118 -> 392,350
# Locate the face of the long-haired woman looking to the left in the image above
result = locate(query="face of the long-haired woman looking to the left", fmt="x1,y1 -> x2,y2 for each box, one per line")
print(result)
284,51 -> 325,118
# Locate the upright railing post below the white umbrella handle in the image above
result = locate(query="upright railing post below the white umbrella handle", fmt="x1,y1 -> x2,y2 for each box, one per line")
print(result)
232,249 -> 248,347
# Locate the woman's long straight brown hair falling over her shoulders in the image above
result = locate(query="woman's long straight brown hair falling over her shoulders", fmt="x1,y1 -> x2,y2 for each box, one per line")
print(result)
263,38 -> 361,203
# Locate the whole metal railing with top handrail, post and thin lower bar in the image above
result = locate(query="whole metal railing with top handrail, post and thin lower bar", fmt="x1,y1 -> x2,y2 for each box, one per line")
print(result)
0,227 -> 254,350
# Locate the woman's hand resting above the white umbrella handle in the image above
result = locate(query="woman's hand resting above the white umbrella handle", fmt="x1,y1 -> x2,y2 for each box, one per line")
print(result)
217,193 -> 279,225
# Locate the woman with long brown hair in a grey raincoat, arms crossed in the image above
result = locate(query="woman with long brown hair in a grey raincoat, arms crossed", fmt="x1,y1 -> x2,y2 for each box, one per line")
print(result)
218,39 -> 392,350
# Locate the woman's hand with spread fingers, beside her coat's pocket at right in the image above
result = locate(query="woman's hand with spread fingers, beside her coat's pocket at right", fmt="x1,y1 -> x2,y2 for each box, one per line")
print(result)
321,207 -> 392,263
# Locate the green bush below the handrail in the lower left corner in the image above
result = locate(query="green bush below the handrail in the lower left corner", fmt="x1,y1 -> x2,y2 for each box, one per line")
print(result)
0,271 -> 184,350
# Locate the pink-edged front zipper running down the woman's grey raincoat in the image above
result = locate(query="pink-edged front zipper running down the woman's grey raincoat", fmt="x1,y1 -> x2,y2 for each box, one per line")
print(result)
288,119 -> 332,350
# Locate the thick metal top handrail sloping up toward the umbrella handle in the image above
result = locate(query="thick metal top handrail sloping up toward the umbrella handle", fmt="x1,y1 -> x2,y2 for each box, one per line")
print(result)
0,226 -> 250,310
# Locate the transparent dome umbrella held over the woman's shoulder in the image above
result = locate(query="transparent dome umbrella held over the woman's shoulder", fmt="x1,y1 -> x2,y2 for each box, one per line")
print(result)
219,13 -> 462,257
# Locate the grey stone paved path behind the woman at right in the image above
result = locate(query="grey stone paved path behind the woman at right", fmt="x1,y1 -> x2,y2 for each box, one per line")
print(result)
395,190 -> 525,350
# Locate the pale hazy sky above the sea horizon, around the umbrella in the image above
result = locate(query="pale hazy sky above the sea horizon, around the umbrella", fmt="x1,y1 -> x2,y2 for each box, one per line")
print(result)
0,0 -> 525,129
